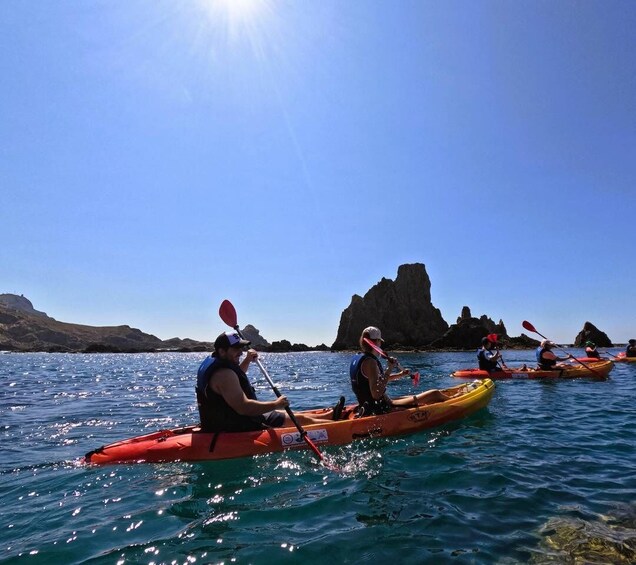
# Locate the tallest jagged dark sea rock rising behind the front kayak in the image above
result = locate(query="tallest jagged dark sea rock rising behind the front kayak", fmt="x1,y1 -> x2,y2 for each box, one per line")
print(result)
332,263 -> 448,350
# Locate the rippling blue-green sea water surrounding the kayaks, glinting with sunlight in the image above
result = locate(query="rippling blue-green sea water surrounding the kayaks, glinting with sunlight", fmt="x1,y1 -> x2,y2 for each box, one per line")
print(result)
0,350 -> 636,565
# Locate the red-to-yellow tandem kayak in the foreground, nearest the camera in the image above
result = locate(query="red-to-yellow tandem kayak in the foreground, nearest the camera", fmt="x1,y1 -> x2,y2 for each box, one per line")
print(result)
84,379 -> 495,464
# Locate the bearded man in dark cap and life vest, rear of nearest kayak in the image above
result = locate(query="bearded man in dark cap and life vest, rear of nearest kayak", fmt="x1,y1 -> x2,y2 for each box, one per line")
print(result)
196,332 -> 344,432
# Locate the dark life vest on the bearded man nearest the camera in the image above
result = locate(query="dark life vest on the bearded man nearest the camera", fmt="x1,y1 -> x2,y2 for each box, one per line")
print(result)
195,355 -> 265,432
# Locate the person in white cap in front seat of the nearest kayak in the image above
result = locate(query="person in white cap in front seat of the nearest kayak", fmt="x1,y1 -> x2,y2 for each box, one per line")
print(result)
349,326 -> 452,416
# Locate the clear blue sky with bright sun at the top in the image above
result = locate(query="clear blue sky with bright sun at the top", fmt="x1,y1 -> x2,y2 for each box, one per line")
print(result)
0,0 -> 636,345
